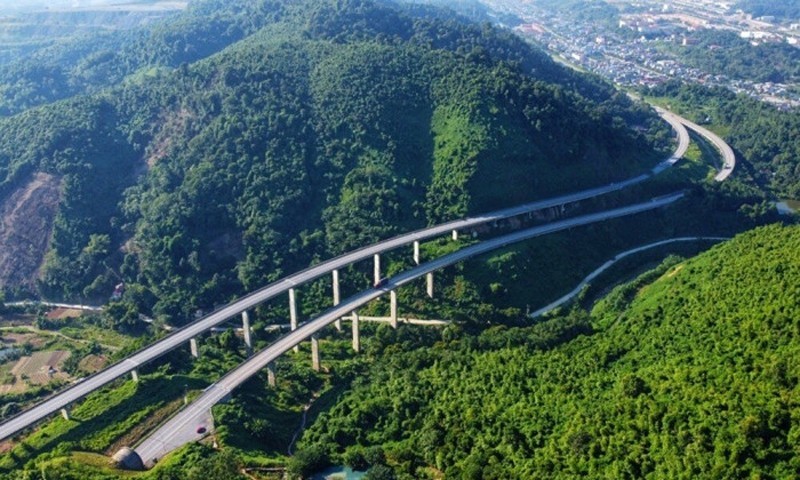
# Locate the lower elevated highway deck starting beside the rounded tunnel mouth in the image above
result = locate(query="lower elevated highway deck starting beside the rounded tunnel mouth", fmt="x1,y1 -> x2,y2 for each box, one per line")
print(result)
136,193 -> 683,465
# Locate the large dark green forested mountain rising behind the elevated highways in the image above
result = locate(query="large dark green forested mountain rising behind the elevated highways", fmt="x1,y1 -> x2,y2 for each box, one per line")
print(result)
0,0 -> 671,323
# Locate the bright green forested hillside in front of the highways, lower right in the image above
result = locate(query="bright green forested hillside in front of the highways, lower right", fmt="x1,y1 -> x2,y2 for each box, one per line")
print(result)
303,226 -> 800,479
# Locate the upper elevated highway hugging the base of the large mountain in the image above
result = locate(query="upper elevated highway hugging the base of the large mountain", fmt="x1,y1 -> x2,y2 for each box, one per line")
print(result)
0,108 -> 688,440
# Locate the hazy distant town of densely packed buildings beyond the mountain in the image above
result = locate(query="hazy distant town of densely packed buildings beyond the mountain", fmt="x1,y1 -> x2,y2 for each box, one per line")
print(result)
485,0 -> 800,109
